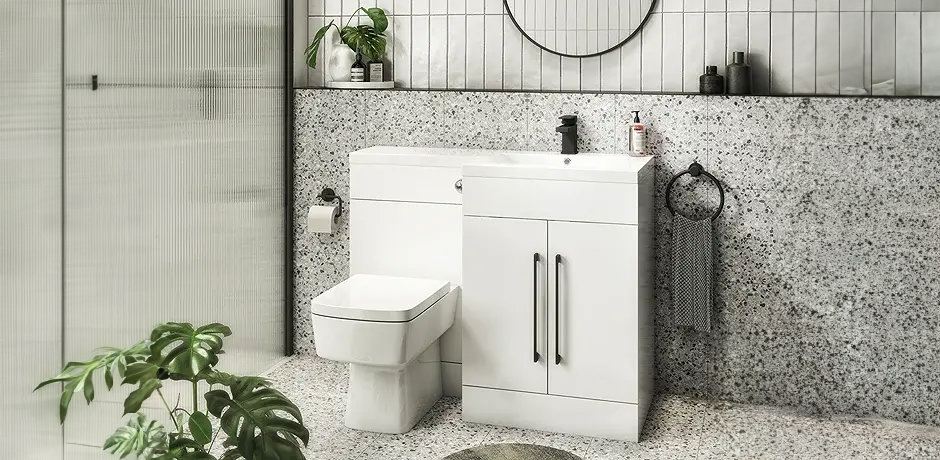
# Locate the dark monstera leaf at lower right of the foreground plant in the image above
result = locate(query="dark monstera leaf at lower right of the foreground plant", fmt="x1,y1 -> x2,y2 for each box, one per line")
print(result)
206,377 -> 310,460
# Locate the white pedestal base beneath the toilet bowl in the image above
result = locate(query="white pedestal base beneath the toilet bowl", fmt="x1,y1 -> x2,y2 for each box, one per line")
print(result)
345,340 -> 442,434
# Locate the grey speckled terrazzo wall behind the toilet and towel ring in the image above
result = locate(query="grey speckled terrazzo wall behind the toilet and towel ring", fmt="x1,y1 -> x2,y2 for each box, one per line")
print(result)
295,89 -> 940,425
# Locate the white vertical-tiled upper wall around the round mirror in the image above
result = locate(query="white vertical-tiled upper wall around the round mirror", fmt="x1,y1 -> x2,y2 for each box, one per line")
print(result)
306,0 -> 940,95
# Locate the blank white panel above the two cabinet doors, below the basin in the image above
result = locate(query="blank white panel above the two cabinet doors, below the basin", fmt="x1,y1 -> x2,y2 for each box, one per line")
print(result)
463,177 -> 640,225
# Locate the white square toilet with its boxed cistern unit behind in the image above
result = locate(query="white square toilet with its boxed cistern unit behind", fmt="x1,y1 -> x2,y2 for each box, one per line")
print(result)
311,147 -> 480,434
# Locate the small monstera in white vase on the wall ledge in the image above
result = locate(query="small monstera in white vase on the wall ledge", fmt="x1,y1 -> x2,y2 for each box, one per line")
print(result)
304,7 -> 388,81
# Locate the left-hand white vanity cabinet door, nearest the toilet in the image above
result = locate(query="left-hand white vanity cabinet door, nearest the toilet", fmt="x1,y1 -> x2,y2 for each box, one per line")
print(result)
462,217 -> 548,393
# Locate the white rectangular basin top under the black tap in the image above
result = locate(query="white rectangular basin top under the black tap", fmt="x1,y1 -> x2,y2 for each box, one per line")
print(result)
463,152 -> 652,183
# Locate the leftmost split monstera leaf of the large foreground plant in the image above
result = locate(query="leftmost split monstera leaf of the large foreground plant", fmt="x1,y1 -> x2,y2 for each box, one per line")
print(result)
33,342 -> 150,422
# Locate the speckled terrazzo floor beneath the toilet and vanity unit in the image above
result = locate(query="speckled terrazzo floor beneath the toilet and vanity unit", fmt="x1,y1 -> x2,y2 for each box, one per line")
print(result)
268,356 -> 940,460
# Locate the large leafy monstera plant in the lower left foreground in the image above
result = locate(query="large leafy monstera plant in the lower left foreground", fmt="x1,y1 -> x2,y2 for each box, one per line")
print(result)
34,323 -> 310,460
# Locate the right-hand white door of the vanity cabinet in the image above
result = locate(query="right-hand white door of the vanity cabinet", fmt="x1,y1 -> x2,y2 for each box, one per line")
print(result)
548,222 -> 638,403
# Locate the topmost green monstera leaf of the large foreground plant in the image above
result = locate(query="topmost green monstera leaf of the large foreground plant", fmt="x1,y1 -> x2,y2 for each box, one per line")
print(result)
150,323 -> 232,378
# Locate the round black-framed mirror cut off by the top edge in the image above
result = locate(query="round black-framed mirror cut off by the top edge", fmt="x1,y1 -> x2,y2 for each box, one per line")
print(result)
503,0 -> 658,58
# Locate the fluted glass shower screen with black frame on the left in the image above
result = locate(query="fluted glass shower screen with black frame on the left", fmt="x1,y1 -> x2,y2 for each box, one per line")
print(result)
0,0 -> 291,460
